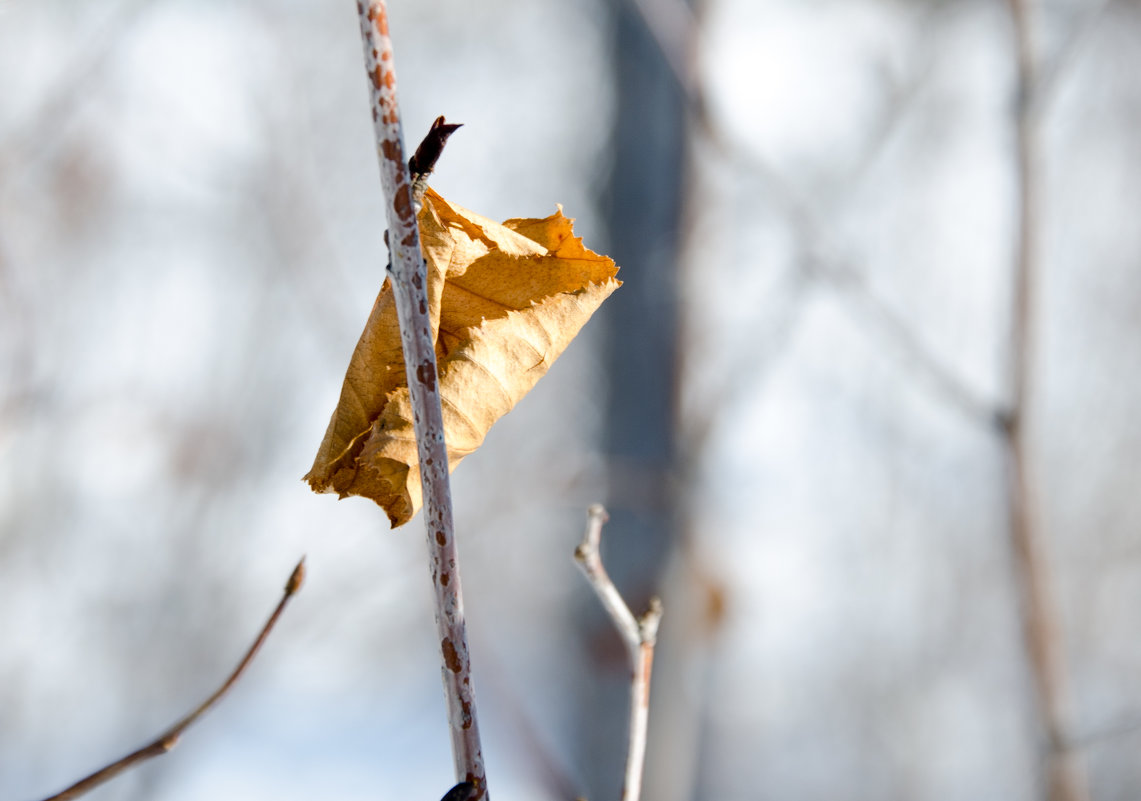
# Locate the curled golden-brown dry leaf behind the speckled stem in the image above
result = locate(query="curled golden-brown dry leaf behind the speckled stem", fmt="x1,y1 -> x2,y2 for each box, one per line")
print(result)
305,189 -> 622,527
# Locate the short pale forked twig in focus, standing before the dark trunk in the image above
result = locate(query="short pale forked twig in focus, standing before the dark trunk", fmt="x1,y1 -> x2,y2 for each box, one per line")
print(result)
574,503 -> 662,801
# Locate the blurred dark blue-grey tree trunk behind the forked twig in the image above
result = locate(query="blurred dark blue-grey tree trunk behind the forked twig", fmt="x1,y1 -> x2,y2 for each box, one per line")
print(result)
575,2 -> 686,799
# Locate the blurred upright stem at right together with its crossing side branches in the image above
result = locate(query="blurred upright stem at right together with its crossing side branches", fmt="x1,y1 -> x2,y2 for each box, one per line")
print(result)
634,0 -> 1136,799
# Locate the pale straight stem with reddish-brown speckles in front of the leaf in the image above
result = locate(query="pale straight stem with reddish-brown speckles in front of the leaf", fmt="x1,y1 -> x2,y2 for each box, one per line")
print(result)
357,0 -> 487,798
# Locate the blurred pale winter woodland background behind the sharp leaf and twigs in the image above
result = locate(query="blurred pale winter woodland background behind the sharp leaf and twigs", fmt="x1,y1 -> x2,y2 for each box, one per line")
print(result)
0,0 -> 1141,801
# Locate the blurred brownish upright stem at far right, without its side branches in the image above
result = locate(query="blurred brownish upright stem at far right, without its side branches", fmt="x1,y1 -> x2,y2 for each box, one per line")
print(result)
1003,0 -> 1090,801
